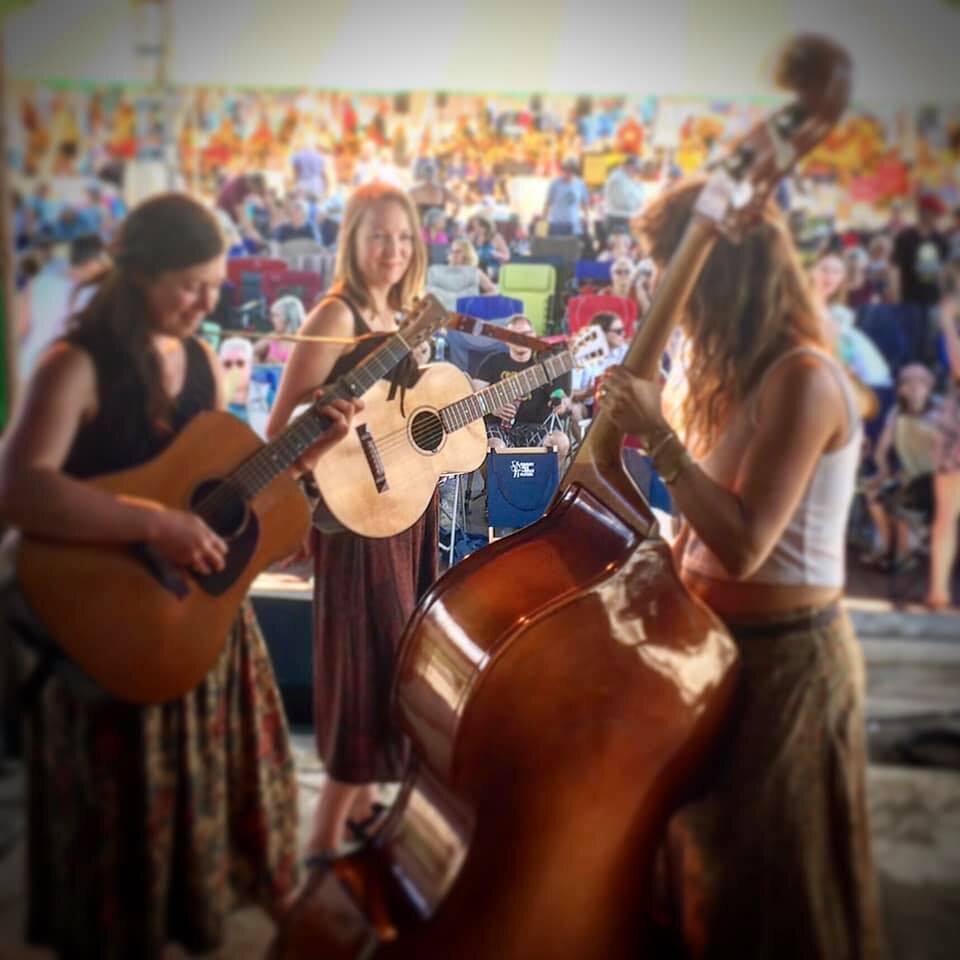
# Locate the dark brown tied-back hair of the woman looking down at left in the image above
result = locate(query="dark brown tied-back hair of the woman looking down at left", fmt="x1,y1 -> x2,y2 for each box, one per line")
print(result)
68,193 -> 225,424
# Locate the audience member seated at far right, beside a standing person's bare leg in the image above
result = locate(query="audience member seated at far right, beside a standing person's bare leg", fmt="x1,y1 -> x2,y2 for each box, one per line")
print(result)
864,363 -> 939,568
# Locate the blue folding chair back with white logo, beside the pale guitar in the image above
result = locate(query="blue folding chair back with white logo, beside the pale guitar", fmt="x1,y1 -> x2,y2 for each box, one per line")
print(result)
487,447 -> 560,540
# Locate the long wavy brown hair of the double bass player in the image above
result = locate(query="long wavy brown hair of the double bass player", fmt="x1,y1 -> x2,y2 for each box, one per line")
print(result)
643,178 -> 827,454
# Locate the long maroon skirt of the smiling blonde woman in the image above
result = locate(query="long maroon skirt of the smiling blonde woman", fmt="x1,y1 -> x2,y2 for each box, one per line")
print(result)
313,497 -> 438,783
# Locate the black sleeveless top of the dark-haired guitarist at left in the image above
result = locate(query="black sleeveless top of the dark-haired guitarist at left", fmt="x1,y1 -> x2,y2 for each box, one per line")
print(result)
63,336 -> 216,479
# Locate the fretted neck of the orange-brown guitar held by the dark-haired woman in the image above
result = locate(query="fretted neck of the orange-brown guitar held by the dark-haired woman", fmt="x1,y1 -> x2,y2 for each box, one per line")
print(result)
226,333 -> 418,500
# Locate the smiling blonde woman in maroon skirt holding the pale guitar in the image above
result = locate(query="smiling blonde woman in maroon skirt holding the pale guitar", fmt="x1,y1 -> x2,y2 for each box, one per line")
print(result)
267,183 -> 437,853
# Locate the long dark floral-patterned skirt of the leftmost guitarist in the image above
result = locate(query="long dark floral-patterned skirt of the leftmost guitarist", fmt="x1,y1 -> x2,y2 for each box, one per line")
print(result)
19,603 -> 297,960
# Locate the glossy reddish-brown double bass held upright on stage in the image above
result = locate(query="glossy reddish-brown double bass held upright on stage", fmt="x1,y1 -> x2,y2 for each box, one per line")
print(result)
273,35 -> 851,960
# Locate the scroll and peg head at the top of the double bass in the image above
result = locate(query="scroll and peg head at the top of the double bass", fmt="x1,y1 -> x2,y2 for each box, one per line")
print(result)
696,34 -> 853,240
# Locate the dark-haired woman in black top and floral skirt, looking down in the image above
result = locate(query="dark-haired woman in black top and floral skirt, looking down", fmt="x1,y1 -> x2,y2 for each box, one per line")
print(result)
0,194 -> 360,958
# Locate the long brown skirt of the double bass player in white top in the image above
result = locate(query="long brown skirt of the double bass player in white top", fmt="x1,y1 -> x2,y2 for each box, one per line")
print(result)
661,608 -> 880,960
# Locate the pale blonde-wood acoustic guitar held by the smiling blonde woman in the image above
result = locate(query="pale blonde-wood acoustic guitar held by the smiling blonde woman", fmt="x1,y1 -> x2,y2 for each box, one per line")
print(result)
314,326 -> 609,537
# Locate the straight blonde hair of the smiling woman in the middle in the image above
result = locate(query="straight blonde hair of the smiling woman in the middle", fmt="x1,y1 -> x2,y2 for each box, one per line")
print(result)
333,181 -> 427,310
